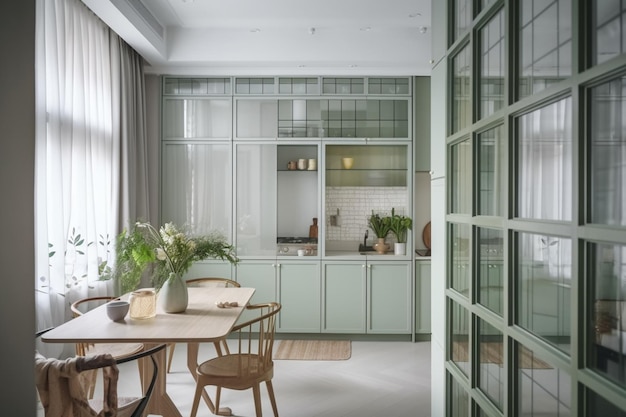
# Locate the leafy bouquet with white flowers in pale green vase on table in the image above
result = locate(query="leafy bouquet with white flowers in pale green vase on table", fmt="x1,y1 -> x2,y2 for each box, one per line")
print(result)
116,222 -> 239,313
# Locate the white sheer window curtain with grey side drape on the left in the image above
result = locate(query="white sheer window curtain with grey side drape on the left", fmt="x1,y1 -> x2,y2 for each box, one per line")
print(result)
35,0 -> 148,329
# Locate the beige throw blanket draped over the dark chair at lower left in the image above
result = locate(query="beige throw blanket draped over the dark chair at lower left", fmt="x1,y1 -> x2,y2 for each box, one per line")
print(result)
35,352 -> 119,417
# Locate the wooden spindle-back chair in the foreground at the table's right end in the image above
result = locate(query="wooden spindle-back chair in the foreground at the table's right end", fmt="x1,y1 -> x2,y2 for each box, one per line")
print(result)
191,302 -> 281,417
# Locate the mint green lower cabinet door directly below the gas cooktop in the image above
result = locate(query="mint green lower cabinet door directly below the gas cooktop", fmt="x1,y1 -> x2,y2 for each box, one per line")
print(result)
276,260 -> 321,333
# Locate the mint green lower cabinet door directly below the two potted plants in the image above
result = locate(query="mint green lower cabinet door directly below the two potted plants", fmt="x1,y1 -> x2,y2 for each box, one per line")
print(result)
366,260 -> 412,334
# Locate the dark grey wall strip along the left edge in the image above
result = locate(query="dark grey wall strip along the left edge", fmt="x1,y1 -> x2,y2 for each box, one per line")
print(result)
0,0 -> 36,417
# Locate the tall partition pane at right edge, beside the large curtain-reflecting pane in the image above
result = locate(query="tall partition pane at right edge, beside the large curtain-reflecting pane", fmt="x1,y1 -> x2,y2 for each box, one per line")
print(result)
590,77 -> 626,226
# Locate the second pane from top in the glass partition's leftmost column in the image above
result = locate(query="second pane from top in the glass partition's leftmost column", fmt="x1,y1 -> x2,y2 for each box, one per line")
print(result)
452,46 -> 472,133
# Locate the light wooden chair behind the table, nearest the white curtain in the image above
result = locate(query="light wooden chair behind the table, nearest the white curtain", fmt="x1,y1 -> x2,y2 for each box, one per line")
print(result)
70,296 -> 144,398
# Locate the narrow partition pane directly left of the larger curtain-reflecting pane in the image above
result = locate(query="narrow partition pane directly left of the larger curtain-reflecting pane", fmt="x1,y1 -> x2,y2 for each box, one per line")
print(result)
477,126 -> 507,216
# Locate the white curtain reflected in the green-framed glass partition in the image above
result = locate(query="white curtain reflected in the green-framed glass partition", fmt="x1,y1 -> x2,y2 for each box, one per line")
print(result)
518,98 -> 574,280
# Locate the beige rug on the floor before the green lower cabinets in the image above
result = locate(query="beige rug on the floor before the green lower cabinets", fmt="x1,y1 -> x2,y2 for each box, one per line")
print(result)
274,340 -> 352,361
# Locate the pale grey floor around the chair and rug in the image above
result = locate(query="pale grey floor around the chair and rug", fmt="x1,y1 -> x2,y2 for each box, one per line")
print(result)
147,341 -> 430,417
